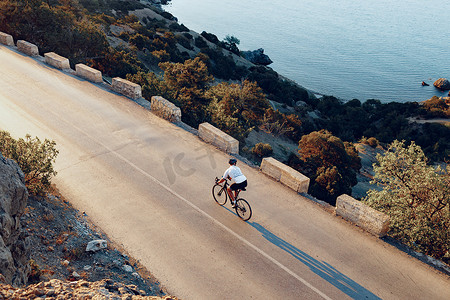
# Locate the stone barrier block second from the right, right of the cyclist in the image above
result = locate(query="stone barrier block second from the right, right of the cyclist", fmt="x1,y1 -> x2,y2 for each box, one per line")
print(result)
260,157 -> 310,193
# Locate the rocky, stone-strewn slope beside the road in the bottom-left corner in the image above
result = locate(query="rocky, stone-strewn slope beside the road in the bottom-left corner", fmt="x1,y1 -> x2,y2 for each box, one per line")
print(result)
0,154 -> 174,299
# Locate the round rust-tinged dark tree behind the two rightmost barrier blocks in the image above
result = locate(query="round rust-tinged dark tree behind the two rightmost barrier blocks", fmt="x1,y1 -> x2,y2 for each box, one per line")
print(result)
294,130 -> 361,205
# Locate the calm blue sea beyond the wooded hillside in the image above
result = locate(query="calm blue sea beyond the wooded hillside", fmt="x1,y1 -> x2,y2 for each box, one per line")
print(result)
163,0 -> 450,103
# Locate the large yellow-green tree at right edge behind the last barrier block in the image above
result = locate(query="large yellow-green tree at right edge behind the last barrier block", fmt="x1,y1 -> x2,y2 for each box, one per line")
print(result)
364,140 -> 450,259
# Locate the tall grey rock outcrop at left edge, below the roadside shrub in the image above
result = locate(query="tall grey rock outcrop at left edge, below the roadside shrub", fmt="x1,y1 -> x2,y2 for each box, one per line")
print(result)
0,153 -> 31,286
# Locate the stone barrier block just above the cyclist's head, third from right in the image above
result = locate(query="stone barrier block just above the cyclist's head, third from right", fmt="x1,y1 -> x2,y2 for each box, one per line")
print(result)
198,122 -> 239,154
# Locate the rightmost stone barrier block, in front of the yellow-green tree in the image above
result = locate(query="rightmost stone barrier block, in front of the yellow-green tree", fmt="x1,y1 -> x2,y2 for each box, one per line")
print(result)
336,194 -> 389,237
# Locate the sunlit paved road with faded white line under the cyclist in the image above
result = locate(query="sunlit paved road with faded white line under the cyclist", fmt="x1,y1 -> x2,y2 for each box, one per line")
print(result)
0,46 -> 450,299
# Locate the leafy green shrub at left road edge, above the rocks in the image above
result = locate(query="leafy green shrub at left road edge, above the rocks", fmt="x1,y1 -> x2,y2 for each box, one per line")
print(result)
0,131 -> 59,195
